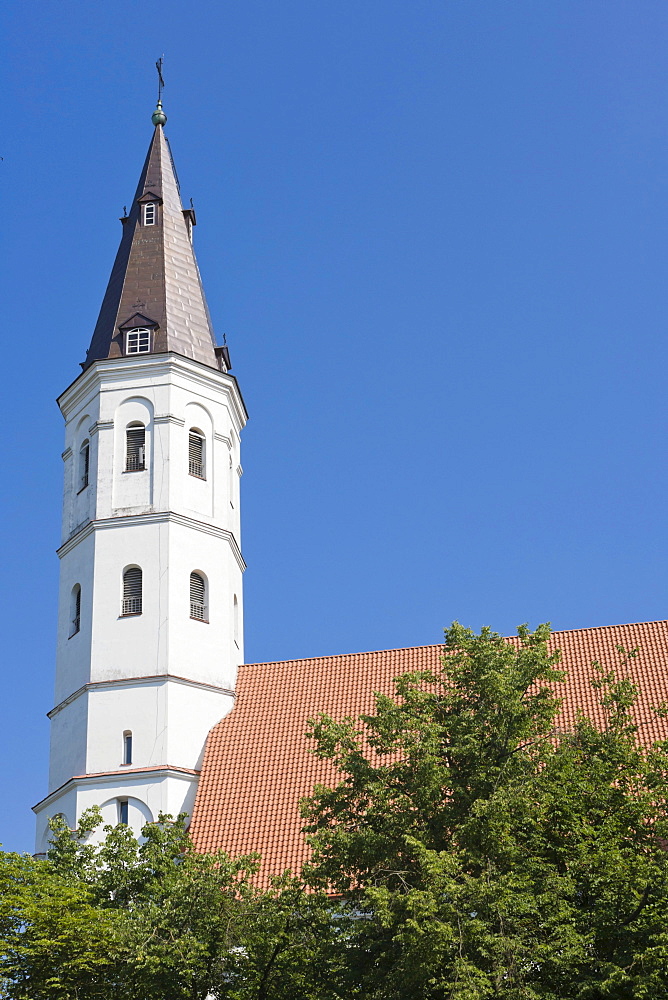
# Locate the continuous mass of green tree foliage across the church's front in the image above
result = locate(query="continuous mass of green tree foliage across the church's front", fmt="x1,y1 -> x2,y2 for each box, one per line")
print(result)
0,624 -> 668,1000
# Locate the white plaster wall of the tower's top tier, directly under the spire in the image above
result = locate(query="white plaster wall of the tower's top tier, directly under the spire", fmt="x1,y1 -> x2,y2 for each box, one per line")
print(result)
59,354 -> 245,540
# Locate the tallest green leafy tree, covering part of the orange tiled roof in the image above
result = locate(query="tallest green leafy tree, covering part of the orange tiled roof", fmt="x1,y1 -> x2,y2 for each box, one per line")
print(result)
303,623 -> 668,1000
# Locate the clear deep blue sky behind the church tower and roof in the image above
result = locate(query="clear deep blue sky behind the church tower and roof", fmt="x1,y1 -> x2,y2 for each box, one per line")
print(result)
0,0 -> 668,850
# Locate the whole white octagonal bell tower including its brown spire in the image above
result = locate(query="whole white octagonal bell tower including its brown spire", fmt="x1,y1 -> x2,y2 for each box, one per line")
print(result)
34,101 -> 247,852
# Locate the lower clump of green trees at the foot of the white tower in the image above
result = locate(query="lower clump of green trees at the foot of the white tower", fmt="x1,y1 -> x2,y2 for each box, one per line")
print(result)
0,809 -> 340,1000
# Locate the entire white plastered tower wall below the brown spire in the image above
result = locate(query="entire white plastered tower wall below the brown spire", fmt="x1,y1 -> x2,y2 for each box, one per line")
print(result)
35,353 -> 245,850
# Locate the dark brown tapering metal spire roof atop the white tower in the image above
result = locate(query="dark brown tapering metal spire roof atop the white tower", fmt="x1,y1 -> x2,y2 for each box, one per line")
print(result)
83,125 -> 219,368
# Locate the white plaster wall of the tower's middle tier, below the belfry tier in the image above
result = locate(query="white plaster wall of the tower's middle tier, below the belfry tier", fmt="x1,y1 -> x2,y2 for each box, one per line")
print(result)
62,514 -> 243,688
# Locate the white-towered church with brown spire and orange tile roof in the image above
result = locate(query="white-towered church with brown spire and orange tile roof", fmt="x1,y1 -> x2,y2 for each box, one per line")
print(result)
34,101 -> 668,880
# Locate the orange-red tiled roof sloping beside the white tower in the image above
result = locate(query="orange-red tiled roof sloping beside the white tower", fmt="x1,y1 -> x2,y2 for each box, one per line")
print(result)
190,621 -> 668,880
